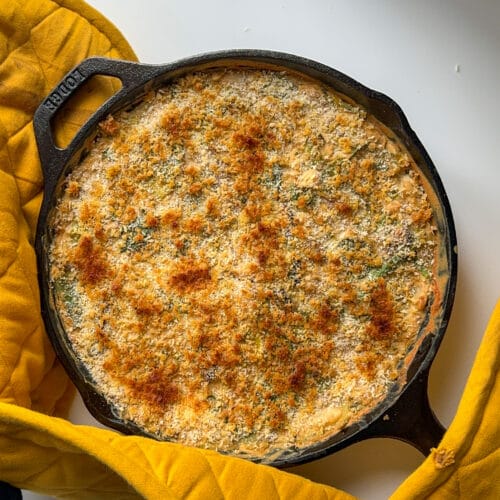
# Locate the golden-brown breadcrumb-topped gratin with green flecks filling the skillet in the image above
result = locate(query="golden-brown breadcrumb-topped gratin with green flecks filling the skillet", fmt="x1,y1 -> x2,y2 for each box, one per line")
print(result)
49,68 -> 438,459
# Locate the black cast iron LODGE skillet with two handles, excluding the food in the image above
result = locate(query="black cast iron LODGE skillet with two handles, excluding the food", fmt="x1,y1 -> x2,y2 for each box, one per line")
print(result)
34,50 -> 457,467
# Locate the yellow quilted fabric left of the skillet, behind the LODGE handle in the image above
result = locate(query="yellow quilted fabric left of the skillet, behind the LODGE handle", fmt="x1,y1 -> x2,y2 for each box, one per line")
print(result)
0,0 -> 136,412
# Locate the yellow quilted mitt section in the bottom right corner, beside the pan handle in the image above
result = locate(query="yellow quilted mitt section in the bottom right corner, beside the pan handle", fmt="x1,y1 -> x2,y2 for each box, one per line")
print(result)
391,302 -> 500,500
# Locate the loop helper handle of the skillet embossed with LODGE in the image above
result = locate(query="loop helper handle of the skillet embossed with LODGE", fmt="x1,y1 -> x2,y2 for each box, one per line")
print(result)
33,57 -> 161,186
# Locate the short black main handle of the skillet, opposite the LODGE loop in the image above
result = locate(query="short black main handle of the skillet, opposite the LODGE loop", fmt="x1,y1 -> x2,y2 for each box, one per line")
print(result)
356,370 -> 446,456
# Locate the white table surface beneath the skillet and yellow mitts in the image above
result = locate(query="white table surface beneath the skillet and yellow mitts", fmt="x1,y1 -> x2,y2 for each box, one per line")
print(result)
25,0 -> 500,500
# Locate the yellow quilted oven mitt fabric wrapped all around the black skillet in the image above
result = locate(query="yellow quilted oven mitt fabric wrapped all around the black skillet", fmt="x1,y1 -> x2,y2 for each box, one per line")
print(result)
0,0 -> 500,499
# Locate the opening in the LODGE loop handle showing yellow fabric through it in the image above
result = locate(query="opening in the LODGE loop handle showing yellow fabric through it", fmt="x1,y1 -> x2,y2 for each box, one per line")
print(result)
50,75 -> 122,149
